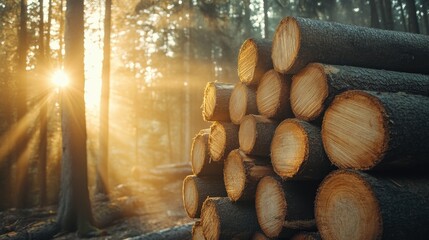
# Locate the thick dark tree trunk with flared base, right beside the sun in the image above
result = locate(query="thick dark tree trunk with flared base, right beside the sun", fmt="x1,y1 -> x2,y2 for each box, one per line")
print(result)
57,0 -> 98,236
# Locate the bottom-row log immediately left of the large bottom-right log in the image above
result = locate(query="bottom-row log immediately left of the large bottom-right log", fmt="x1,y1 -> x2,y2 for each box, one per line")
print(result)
255,176 -> 318,238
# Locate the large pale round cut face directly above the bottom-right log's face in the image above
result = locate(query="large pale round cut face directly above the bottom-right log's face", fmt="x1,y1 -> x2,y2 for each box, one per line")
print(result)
322,91 -> 389,170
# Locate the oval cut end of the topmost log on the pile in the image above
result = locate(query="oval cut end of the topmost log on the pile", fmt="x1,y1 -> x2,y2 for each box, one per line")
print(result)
271,17 -> 301,73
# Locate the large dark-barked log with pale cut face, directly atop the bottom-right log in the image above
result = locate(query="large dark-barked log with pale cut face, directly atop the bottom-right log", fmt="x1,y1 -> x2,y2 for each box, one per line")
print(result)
322,90 -> 429,170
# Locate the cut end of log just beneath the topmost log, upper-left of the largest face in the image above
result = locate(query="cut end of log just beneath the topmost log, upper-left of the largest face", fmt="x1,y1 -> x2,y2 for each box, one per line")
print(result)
290,63 -> 328,121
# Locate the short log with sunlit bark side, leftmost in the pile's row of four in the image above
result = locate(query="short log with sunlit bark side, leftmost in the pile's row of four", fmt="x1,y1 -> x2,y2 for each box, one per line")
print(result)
203,82 -> 234,121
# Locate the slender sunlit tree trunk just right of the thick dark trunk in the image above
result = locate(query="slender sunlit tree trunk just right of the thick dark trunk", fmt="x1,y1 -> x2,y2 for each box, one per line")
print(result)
95,0 -> 112,194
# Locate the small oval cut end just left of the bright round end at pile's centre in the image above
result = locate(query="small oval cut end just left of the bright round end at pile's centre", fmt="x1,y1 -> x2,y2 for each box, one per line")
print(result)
238,115 -> 257,154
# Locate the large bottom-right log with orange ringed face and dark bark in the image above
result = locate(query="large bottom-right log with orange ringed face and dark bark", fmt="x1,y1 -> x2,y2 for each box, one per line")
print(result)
315,170 -> 429,240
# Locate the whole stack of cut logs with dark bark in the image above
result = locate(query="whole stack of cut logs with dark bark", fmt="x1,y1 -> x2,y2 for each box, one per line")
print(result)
183,17 -> 429,239
